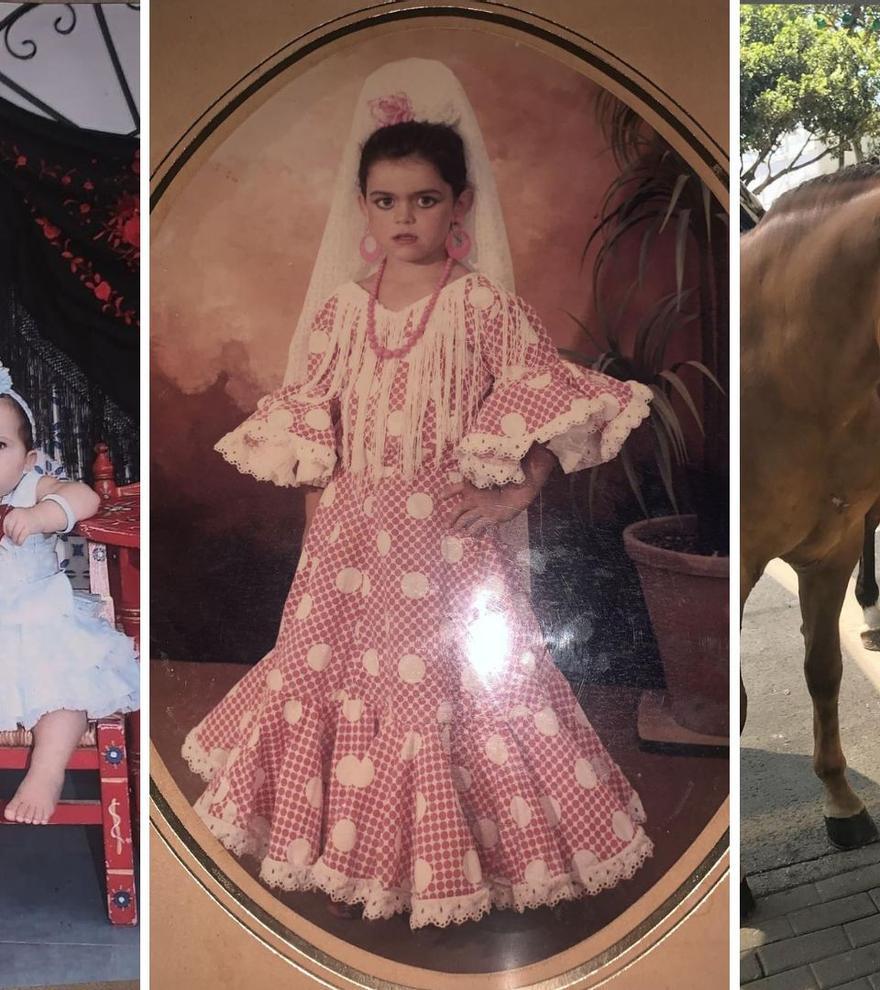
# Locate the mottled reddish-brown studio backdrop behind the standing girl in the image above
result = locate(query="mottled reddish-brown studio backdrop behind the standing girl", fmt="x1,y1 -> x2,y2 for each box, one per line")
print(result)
151,30 -> 727,971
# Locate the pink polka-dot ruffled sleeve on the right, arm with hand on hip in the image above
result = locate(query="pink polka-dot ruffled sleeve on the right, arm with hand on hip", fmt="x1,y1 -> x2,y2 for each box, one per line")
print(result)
458,285 -> 651,488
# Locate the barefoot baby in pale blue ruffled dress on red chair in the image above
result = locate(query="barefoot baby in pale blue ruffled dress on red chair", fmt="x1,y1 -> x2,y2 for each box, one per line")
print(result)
0,367 -> 139,825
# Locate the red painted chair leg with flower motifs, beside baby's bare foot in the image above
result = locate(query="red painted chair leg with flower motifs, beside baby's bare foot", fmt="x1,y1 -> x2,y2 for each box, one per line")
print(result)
97,717 -> 137,925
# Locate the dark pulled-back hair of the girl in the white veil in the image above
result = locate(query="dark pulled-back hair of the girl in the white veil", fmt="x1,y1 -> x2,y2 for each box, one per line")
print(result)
358,120 -> 467,199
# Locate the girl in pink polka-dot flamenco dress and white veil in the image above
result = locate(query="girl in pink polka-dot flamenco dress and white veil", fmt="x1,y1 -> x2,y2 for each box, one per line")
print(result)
184,59 -> 652,928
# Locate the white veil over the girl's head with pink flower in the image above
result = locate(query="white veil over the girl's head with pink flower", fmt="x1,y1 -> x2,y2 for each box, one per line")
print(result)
284,58 -> 514,385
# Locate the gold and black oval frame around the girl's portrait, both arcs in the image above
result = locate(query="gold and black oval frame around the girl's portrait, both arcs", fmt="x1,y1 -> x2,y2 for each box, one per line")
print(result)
150,5 -> 729,990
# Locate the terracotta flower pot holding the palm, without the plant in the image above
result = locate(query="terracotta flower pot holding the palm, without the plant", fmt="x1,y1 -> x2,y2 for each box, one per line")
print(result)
623,516 -> 730,736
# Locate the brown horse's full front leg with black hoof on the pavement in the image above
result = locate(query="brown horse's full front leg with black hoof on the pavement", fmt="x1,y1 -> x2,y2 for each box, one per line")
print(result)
798,530 -> 878,849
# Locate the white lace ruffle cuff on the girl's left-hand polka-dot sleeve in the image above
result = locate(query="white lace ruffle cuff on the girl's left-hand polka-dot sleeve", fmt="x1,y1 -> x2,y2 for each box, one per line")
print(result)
214,420 -> 336,488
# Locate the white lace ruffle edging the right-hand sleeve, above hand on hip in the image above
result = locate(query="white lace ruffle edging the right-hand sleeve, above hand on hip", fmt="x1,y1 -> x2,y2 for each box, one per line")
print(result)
458,381 -> 652,488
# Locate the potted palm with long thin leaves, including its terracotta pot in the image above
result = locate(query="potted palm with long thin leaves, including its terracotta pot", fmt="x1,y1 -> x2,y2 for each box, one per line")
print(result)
564,94 -> 729,743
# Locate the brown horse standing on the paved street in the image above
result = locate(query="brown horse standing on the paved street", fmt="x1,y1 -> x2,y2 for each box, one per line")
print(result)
740,165 -> 880,868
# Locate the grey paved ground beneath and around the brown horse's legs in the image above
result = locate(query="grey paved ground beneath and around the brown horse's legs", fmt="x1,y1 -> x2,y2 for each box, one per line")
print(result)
740,536 -> 880,990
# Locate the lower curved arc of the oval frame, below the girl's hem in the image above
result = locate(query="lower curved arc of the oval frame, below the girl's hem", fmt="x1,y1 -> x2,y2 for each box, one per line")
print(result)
150,747 -> 729,990
